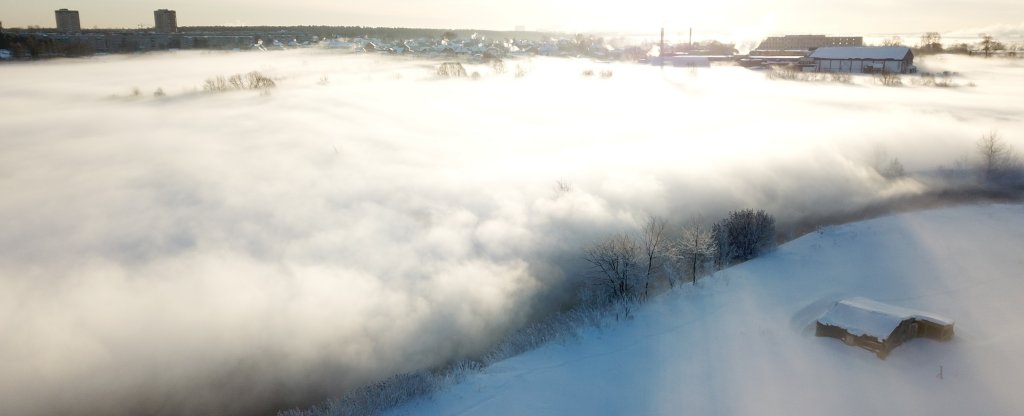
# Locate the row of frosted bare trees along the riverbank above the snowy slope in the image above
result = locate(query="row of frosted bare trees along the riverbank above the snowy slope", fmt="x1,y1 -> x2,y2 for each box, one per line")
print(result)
584,209 -> 775,301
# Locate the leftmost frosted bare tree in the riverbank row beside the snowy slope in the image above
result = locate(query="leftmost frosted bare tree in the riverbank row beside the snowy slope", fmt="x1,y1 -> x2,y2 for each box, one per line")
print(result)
584,234 -> 643,301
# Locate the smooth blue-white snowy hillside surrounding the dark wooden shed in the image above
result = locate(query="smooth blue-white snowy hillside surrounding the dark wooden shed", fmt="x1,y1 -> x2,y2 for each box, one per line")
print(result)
392,205 -> 1024,415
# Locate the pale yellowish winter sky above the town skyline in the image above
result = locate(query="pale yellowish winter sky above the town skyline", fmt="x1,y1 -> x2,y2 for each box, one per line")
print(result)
0,0 -> 1024,37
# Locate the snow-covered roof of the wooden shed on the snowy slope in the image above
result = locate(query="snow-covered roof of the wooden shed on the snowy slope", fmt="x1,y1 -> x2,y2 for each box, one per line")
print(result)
818,297 -> 953,341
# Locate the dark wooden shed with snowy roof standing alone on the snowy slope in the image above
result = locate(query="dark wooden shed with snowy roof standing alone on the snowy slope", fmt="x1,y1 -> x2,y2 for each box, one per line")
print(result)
815,297 -> 953,360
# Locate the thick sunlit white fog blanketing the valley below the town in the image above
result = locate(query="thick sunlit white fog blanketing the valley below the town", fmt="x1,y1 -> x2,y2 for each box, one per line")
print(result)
0,50 -> 1024,415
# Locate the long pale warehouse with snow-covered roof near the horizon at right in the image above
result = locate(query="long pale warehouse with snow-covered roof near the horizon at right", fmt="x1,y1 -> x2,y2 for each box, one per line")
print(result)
809,46 -> 916,74
